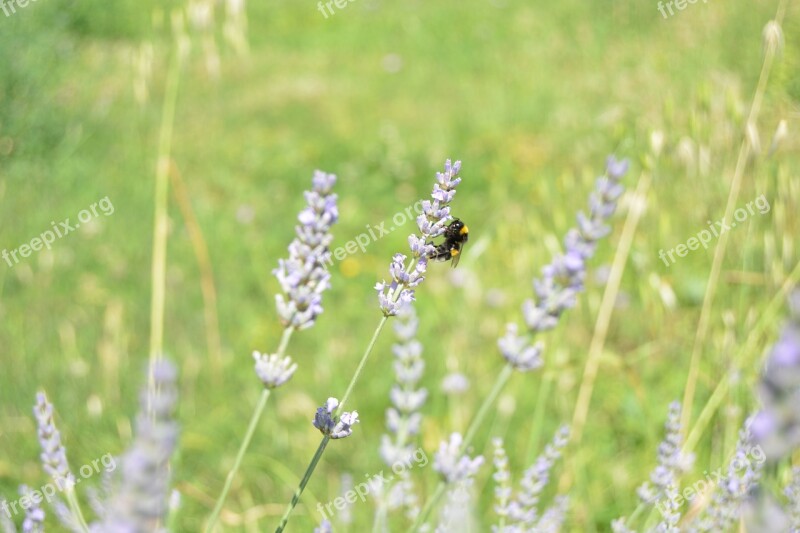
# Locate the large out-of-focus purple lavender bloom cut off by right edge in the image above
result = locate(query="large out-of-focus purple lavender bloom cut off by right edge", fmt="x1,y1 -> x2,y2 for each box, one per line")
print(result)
750,290 -> 800,462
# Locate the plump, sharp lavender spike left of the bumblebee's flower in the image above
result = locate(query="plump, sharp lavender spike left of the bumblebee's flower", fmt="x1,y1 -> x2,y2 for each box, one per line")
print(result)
272,171 -> 339,329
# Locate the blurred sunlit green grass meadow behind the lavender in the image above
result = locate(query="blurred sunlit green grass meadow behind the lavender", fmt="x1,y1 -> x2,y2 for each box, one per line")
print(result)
0,0 -> 800,531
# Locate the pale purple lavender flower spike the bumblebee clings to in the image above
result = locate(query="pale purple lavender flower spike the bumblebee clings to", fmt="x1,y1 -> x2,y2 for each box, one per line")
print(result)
375,159 -> 461,316
